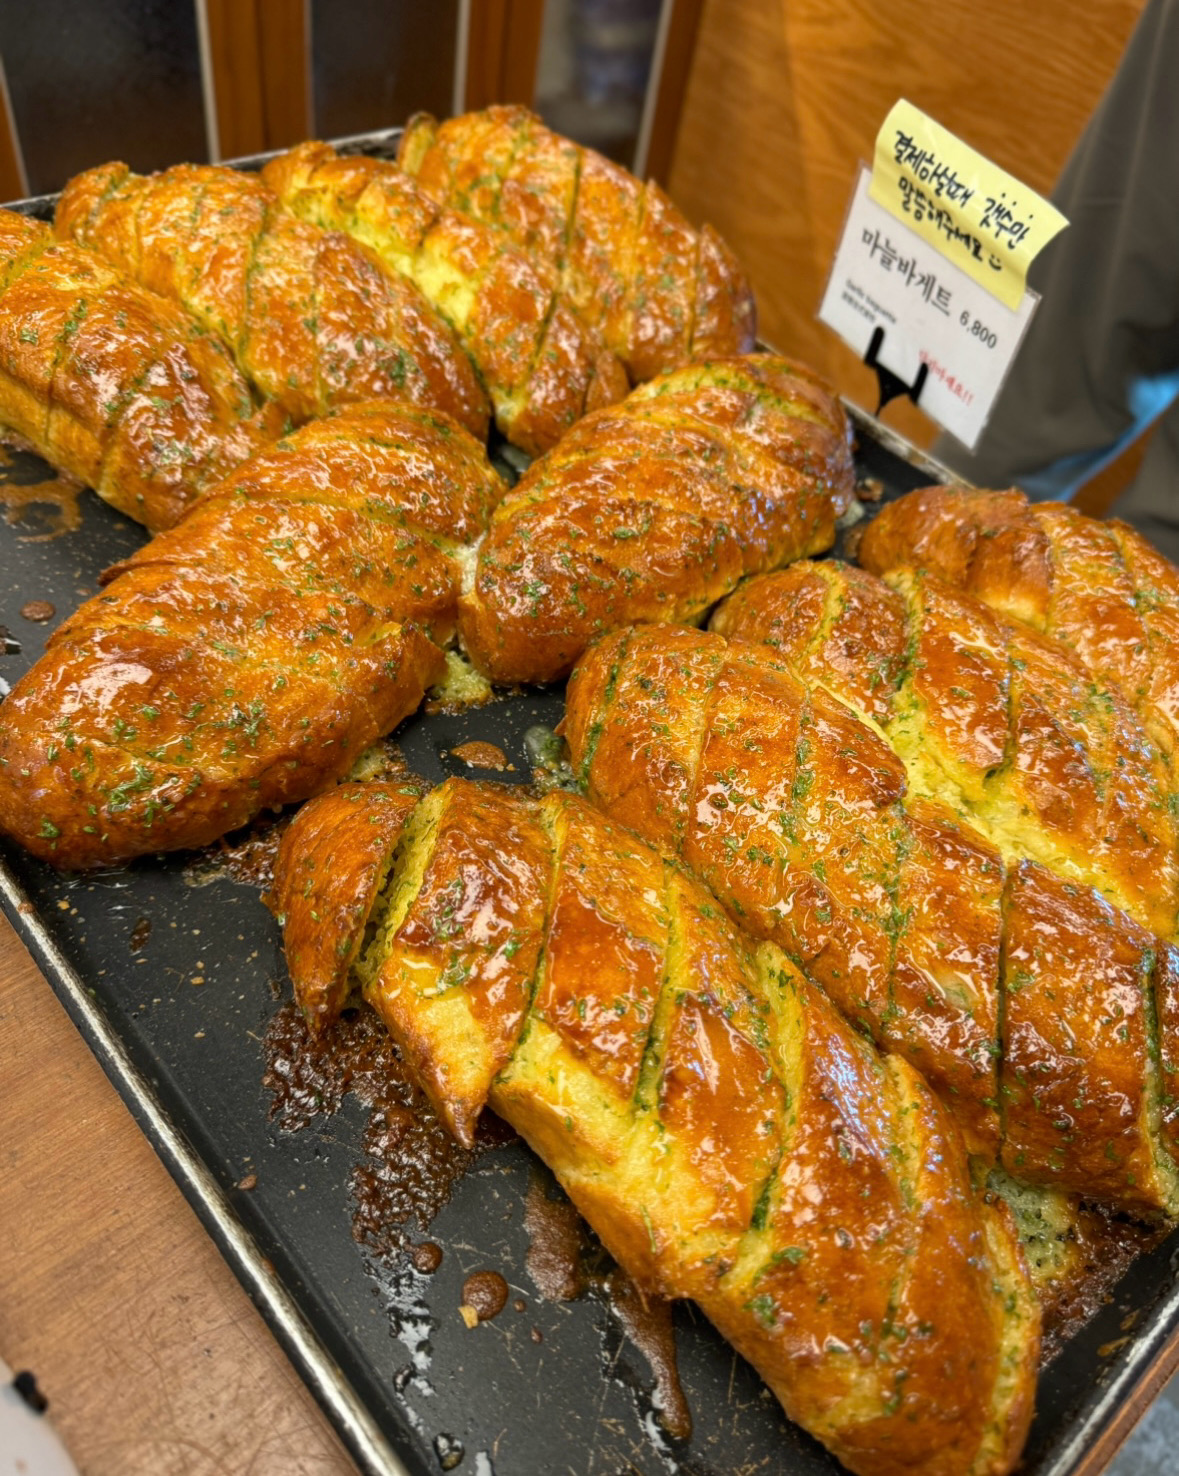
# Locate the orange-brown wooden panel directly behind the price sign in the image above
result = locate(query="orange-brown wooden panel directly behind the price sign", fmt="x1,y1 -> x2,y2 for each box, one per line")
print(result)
670,0 -> 1144,460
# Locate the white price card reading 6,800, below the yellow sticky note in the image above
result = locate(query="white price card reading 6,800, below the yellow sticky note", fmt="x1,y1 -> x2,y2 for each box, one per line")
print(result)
819,167 -> 1040,447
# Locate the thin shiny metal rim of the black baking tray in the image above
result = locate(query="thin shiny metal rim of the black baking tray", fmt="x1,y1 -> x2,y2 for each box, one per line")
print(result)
0,125 -> 1179,1476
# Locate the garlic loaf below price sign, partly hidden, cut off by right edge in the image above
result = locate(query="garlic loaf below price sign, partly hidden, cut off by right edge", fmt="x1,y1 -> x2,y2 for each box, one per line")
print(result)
857,487 -> 1179,751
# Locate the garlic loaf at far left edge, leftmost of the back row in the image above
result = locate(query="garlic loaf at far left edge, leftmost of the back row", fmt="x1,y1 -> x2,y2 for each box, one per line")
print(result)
0,210 -> 271,528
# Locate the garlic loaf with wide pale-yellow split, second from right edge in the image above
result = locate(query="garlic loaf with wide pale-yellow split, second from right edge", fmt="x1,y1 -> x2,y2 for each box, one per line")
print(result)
713,561 -> 1179,939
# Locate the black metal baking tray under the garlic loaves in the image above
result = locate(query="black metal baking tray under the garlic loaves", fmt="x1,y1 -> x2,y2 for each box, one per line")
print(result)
0,130 -> 1179,1476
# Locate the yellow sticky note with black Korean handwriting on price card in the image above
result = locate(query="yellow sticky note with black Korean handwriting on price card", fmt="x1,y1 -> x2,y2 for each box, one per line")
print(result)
871,97 -> 1068,308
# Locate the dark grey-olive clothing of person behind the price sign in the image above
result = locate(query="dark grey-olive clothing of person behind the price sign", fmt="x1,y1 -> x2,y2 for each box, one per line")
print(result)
934,0 -> 1179,561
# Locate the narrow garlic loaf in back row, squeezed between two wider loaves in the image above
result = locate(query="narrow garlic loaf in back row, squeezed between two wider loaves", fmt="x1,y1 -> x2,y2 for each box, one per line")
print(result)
263,143 -> 629,456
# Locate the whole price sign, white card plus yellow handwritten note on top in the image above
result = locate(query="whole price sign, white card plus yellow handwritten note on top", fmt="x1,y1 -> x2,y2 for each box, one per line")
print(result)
819,100 -> 1068,447
